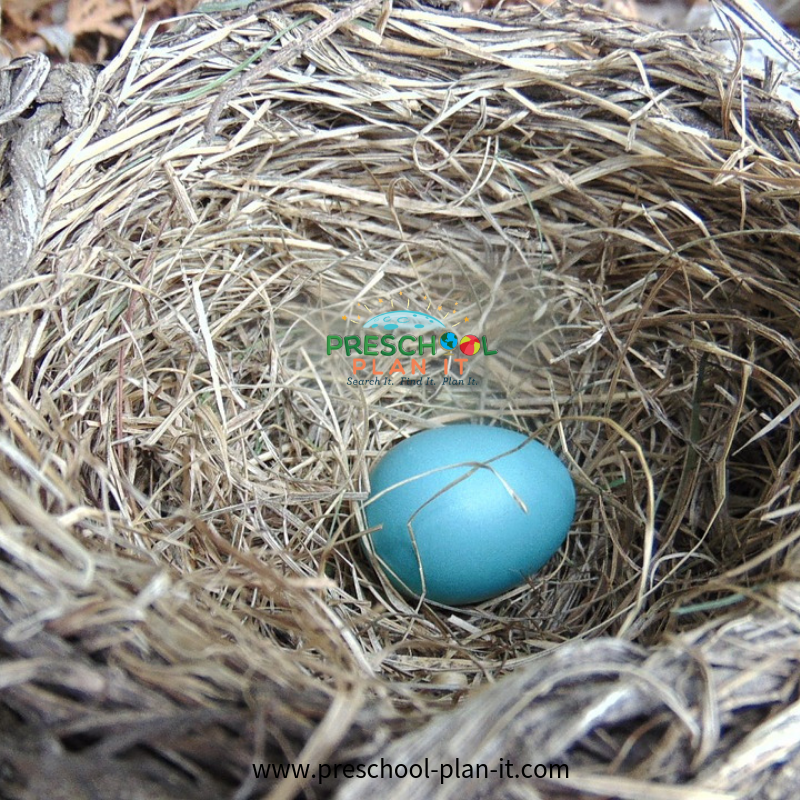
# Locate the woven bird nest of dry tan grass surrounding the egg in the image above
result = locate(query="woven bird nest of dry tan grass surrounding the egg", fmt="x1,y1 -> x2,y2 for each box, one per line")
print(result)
0,2 -> 800,800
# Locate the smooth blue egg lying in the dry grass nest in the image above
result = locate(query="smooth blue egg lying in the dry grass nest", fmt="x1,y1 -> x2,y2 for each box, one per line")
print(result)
365,424 -> 575,605
